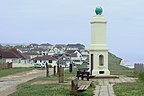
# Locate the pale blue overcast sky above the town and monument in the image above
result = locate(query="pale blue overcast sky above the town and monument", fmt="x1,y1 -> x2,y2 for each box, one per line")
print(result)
0,0 -> 144,60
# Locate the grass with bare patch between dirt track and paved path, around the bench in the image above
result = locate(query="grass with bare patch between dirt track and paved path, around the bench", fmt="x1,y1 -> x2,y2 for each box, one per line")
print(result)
10,70 -> 94,96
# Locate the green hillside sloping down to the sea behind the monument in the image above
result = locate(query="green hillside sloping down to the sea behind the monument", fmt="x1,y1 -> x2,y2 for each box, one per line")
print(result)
108,52 -> 129,73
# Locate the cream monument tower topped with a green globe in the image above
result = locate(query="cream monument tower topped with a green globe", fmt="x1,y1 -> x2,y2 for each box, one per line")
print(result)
89,7 -> 110,76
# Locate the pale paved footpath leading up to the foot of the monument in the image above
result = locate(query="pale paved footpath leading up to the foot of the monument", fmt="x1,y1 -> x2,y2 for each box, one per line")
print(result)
92,76 -> 137,96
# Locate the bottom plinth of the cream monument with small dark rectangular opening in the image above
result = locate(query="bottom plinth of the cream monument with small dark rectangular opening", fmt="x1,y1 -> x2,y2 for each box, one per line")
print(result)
92,69 -> 110,76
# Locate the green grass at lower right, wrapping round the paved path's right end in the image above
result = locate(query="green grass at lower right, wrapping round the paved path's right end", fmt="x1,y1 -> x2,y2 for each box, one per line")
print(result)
114,70 -> 144,96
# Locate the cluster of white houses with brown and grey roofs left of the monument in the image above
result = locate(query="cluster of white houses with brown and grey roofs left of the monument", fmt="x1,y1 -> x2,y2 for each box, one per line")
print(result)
0,43 -> 89,67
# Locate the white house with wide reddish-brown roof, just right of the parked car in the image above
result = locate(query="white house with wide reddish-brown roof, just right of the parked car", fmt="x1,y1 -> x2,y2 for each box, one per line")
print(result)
32,55 -> 57,67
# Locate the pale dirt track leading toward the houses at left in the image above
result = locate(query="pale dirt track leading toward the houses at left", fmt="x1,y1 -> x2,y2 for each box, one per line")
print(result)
0,69 -> 53,96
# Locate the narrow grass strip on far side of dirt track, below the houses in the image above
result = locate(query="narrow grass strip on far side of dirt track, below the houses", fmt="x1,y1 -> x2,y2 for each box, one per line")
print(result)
0,67 -> 33,77
